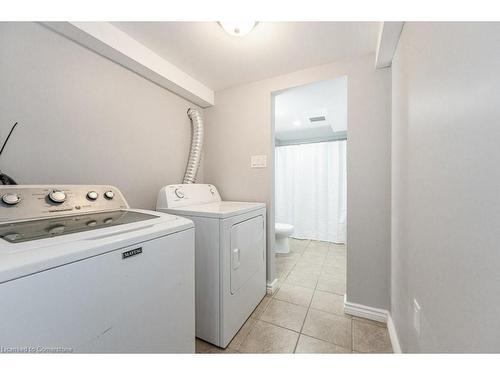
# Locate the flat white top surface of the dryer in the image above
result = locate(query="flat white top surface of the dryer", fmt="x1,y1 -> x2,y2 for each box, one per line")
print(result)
161,201 -> 266,219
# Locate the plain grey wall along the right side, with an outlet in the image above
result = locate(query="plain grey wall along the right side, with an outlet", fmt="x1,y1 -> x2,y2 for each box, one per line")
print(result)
392,22 -> 500,352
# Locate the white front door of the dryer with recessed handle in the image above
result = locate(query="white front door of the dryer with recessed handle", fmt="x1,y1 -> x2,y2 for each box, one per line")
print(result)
230,215 -> 265,294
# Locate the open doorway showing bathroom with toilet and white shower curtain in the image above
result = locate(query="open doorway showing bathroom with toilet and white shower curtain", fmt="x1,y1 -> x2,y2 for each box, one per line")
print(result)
271,76 -> 347,288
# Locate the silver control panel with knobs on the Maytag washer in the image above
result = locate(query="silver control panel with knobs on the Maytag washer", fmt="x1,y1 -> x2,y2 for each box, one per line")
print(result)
0,185 -> 128,222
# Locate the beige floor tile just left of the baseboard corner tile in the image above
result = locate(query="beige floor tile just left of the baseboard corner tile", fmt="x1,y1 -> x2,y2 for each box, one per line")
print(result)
302,309 -> 352,350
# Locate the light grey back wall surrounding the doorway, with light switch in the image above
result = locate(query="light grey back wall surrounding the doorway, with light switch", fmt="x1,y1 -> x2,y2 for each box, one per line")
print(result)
205,55 -> 390,308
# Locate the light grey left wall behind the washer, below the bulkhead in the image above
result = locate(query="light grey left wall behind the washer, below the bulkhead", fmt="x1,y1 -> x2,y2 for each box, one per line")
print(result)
0,22 -> 203,208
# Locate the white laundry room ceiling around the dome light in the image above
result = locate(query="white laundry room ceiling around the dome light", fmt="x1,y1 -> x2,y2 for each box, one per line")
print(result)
113,22 -> 378,91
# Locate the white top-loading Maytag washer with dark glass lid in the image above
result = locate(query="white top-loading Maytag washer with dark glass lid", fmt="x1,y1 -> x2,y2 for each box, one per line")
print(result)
0,185 -> 195,353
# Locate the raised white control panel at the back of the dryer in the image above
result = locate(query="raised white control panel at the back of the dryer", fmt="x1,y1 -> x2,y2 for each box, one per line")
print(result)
156,184 -> 221,210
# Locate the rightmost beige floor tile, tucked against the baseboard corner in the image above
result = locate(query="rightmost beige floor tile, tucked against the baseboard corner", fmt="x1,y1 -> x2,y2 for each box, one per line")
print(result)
352,320 -> 392,353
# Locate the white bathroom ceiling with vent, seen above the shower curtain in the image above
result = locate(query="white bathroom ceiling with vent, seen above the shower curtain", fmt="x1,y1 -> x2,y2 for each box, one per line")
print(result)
274,76 -> 347,142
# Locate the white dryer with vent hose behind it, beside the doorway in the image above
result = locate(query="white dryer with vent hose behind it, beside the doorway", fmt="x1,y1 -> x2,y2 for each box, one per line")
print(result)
156,184 -> 266,348
